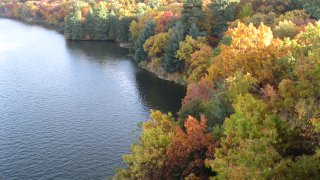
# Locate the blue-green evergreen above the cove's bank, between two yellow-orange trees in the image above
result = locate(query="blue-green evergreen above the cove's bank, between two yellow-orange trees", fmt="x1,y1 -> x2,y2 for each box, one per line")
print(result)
163,21 -> 184,73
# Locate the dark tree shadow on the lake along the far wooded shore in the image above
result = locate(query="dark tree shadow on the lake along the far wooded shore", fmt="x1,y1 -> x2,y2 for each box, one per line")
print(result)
67,41 -> 186,115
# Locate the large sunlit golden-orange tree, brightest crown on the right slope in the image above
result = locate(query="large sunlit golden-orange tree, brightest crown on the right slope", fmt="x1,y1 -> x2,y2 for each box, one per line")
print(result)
208,23 -> 288,82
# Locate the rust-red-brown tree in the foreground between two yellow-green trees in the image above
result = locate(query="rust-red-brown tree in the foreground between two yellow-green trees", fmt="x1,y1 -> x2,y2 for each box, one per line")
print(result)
166,116 -> 220,179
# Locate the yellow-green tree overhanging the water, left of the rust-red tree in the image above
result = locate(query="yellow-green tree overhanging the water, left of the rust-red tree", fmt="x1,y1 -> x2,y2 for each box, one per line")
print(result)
117,111 -> 176,179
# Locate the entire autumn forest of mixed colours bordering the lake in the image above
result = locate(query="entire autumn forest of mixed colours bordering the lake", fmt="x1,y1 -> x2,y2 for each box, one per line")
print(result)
0,0 -> 320,179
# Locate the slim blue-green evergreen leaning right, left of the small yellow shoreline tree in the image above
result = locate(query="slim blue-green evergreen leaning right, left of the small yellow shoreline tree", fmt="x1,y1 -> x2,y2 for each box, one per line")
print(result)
134,20 -> 155,62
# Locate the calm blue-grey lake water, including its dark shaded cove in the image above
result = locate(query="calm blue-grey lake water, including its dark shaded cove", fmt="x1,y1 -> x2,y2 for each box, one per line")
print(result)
0,19 -> 184,180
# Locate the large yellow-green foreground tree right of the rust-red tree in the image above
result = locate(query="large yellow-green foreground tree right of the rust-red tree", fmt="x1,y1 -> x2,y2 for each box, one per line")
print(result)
207,94 -> 282,179
